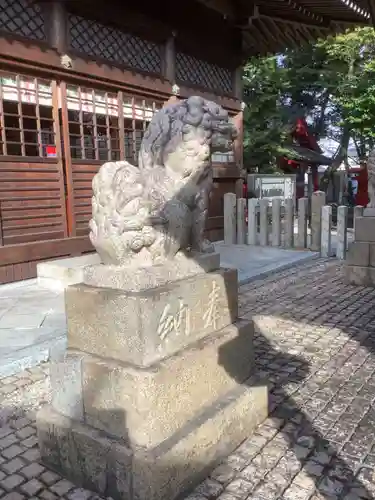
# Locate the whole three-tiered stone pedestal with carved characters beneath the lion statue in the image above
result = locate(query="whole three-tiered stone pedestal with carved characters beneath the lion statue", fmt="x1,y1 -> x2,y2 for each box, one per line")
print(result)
37,260 -> 267,500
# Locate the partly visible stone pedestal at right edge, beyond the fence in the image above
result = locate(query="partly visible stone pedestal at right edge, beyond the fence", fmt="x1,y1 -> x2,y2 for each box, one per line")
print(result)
345,214 -> 375,286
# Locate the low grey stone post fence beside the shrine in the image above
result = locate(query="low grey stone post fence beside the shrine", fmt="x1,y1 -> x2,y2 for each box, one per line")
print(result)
224,191 -> 363,260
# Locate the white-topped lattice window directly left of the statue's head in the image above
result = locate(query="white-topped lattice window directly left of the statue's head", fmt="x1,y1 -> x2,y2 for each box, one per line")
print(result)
66,85 -> 162,164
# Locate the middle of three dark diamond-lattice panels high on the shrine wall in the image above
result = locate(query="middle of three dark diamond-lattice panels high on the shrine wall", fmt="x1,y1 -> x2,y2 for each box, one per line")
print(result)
69,14 -> 162,74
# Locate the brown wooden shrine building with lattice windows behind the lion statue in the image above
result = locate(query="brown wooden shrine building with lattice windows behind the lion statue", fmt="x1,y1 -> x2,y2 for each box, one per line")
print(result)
0,0 -> 372,283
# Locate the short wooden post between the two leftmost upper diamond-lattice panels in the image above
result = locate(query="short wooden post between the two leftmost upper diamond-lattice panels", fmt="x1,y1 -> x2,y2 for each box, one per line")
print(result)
45,0 -> 68,54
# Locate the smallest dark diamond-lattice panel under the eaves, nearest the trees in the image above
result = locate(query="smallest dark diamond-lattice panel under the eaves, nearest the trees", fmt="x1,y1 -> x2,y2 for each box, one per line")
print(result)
176,52 -> 233,95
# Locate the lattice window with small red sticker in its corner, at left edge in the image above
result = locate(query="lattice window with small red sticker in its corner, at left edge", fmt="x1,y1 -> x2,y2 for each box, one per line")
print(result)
0,72 -> 56,158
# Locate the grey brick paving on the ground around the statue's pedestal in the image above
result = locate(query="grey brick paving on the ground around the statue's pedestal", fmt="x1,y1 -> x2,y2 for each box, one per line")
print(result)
0,260 -> 375,500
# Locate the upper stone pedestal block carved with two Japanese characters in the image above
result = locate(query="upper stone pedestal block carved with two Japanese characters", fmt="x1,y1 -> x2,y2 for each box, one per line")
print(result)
65,269 -> 238,366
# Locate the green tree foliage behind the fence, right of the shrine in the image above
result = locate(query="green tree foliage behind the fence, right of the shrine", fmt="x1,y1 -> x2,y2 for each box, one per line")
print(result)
244,27 -> 375,178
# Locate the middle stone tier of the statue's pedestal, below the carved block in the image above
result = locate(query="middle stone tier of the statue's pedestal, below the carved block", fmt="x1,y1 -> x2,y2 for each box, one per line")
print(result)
51,320 -> 254,447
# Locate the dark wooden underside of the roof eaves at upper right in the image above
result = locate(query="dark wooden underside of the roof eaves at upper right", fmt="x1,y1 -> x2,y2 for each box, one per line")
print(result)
199,0 -> 375,57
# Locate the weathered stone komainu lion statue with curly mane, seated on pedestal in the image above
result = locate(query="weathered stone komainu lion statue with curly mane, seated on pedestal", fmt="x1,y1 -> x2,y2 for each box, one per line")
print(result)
90,97 -> 236,266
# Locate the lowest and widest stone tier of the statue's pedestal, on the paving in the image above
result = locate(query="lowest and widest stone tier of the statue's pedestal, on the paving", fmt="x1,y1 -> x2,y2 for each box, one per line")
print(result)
37,385 -> 268,500
